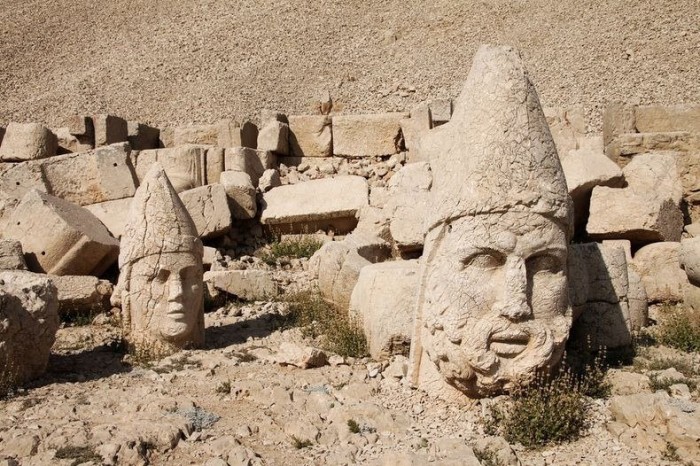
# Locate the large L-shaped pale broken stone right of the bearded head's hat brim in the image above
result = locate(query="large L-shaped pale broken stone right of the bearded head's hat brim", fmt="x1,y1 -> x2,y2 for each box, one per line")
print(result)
586,154 -> 683,242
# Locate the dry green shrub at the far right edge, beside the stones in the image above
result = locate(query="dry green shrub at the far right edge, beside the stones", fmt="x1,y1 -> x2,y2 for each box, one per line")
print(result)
656,305 -> 700,353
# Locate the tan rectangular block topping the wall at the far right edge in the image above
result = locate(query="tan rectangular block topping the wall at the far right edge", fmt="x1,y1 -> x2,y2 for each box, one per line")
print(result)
634,104 -> 700,133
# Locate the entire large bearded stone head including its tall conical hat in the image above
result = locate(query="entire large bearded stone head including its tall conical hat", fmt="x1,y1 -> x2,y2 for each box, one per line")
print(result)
411,46 -> 571,397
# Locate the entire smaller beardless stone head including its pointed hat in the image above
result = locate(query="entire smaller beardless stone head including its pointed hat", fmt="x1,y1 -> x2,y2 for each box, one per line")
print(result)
118,163 -> 204,356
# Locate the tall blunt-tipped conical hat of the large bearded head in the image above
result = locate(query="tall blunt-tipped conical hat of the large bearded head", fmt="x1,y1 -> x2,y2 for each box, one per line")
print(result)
420,45 -> 572,229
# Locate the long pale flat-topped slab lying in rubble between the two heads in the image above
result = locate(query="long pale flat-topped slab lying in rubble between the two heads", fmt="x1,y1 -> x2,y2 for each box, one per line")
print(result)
260,176 -> 369,234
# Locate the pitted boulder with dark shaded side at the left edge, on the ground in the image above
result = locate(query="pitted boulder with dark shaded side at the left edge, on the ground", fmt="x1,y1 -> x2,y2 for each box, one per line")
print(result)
0,271 -> 60,383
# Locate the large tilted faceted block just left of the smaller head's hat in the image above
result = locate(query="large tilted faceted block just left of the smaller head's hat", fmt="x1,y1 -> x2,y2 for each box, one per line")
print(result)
3,190 -> 119,276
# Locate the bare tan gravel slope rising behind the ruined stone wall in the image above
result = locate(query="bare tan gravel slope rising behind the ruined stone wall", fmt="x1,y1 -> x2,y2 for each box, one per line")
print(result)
0,0 -> 700,130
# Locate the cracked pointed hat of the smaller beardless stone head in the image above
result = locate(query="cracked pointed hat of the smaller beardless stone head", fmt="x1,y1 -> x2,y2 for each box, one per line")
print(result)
119,162 -> 203,268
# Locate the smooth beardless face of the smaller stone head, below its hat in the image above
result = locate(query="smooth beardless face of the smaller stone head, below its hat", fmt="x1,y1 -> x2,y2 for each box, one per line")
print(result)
128,252 -> 203,346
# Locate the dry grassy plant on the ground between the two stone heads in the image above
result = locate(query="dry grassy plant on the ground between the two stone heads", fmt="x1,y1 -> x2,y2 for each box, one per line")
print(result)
286,289 -> 367,357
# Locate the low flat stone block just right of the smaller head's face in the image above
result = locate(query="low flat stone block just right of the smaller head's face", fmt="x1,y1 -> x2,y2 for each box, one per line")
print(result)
204,270 -> 279,301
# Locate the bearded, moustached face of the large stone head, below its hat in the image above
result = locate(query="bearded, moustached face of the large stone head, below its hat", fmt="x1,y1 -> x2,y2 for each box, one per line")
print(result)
422,212 -> 571,396
